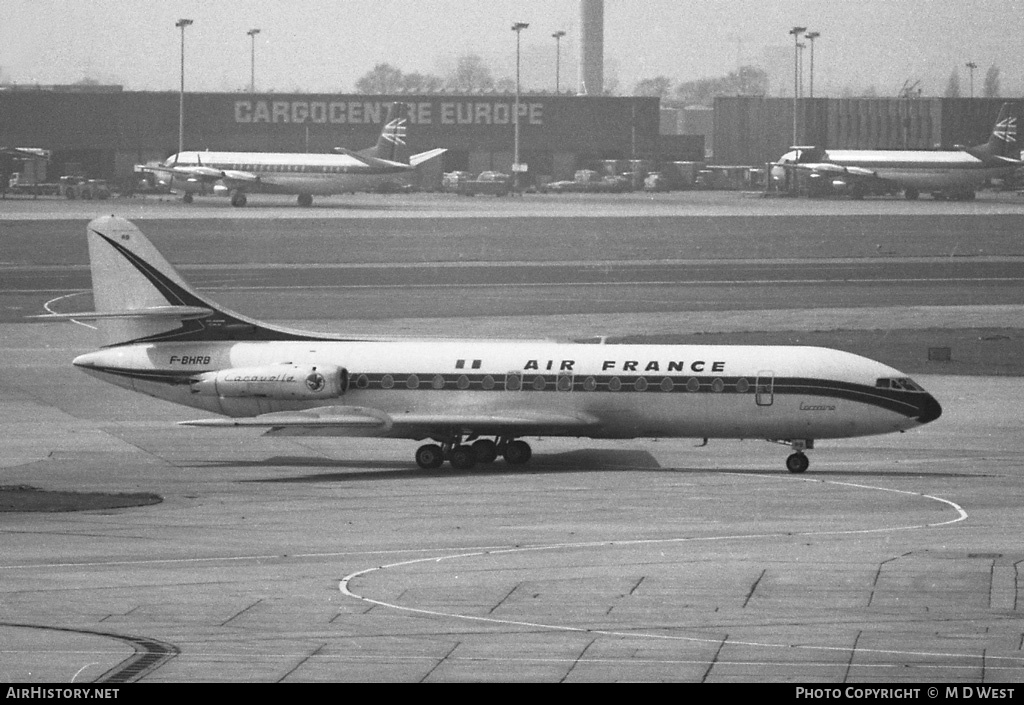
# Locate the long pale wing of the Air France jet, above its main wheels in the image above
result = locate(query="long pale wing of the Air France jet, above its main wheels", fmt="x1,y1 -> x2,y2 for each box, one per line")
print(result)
179,406 -> 598,439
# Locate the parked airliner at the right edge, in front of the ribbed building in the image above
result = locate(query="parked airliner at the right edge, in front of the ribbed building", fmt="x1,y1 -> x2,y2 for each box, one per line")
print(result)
771,102 -> 1024,201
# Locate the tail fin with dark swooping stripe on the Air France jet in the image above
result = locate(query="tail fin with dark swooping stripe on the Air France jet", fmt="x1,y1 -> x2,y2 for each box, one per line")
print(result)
62,216 -> 319,347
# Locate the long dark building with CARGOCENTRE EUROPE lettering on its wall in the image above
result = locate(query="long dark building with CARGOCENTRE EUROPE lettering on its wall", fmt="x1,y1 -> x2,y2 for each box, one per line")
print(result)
0,89 -> 703,182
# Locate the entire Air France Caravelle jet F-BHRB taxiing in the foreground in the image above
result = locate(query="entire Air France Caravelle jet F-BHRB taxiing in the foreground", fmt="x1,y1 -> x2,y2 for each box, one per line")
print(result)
40,216 -> 942,472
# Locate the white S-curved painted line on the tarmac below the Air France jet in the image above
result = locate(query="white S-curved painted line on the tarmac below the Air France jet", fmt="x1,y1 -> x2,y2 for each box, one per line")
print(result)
338,475 -> 1024,664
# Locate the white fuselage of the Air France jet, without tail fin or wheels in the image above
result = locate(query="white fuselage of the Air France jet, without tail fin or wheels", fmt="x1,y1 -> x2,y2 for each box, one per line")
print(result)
75,339 -> 931,439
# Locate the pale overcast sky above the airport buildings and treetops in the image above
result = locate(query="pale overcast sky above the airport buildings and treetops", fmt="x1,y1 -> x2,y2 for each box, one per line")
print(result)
0,0 -> 1024,96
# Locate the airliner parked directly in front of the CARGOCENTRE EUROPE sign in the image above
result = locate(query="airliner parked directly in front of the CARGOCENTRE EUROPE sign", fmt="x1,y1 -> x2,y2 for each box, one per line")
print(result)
139,102 -> 446,208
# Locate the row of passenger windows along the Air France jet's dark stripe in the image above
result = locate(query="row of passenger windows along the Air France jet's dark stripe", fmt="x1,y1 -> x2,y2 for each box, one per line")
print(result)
355,374 -> 751,393
